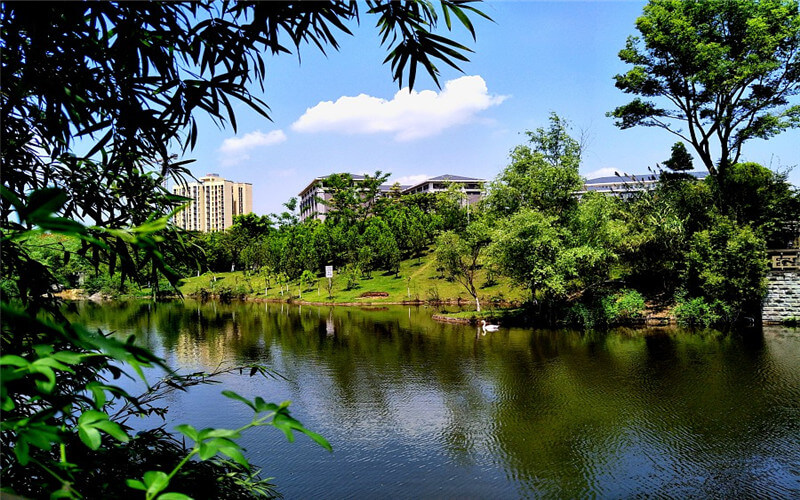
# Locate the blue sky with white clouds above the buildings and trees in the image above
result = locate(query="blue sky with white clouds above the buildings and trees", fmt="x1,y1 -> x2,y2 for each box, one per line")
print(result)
186,1 -> 800,214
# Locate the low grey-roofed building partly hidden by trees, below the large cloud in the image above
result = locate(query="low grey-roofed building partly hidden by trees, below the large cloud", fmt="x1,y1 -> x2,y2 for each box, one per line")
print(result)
298,174 -> 486,220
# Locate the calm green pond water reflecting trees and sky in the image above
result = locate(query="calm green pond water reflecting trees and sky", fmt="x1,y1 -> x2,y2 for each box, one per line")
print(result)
72,301 -> 800,499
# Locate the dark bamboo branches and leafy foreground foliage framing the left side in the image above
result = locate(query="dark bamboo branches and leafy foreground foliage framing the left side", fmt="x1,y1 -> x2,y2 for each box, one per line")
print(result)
0,0 -> 485,498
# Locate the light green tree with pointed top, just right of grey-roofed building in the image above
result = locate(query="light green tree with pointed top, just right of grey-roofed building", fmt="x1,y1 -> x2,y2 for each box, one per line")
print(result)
485,113 -> 583,221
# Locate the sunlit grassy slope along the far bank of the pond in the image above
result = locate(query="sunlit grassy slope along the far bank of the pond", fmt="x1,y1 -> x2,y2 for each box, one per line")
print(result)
180,254 -> 522,305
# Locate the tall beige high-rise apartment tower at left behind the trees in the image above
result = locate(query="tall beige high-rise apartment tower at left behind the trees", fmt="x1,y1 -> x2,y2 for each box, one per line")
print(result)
172,174 -> 253,233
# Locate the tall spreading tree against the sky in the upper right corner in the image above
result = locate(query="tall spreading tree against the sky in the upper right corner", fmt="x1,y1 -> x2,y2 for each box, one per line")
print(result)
609,0 -> 800,176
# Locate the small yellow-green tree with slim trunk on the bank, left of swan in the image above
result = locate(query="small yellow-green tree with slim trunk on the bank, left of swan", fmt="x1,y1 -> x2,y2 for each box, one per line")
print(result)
436,221 -> 491,312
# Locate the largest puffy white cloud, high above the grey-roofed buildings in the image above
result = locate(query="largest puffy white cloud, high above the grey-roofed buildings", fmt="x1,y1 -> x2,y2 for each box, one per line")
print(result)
292,76 -> 508,141
